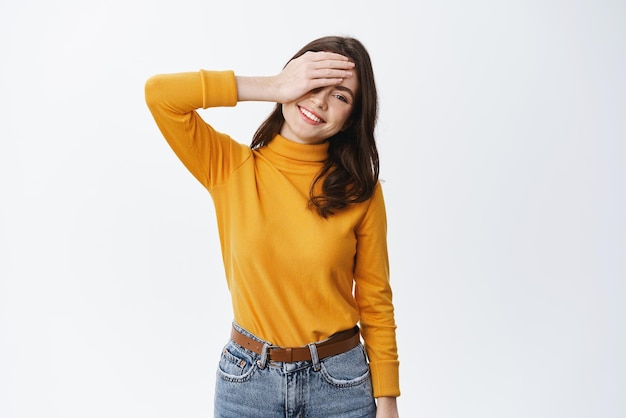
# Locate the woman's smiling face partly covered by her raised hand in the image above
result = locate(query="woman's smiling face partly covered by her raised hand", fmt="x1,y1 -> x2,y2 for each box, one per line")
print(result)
280,76 -> 359,144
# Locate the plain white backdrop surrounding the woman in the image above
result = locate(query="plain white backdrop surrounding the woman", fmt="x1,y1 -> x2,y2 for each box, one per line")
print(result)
0,0 -> 626,418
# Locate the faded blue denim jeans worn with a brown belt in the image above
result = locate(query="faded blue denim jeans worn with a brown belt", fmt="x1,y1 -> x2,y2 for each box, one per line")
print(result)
215,324 -> 376,418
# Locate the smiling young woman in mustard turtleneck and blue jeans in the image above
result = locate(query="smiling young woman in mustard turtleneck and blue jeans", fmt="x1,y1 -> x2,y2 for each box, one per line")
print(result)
146,37 -> 400,418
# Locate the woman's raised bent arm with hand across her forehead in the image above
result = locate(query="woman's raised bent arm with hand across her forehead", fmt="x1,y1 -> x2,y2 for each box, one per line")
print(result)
145,52 -> 354,190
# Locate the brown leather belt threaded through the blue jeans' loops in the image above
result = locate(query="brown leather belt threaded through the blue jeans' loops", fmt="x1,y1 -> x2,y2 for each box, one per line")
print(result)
230,326 -> 361,363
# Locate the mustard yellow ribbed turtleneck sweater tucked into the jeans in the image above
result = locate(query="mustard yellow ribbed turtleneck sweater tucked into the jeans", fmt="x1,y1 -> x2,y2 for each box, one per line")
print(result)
146,71 -> 400,397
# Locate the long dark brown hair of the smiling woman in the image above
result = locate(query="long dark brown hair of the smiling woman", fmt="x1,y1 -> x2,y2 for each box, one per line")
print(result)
251,36 -> 379,218
